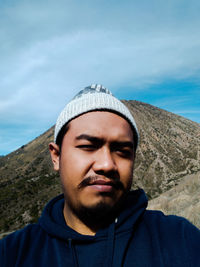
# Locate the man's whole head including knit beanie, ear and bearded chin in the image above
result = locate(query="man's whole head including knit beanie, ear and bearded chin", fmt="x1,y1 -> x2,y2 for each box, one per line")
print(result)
49,85 -> 138,230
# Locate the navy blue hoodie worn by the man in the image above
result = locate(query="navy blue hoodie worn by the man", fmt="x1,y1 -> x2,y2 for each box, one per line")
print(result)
0,190 -> 200,267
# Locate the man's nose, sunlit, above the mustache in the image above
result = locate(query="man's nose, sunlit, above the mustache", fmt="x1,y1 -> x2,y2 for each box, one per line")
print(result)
93,147 -> 117,174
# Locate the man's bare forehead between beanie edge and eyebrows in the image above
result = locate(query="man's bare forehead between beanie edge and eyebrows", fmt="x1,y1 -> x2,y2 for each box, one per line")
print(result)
68,111 -> 133,139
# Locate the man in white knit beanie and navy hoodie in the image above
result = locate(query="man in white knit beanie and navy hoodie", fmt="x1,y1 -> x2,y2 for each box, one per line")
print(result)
0,85 -> 200,267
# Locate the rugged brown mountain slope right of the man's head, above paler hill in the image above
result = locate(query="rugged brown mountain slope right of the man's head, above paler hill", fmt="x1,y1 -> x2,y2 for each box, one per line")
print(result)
125,101 -> 200,198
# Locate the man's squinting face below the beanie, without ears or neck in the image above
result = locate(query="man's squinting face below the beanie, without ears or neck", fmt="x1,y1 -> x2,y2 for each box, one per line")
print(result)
51,111 -> 134,221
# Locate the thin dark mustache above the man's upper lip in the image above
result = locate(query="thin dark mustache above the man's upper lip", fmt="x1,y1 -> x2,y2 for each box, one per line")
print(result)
78,175 -> 124,190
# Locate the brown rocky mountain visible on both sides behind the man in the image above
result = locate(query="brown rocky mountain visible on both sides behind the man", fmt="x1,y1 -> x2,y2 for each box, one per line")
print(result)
0,100 -> 200,237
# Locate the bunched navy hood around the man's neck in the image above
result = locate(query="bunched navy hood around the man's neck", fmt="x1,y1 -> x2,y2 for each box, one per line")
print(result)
39,189 -> 147,241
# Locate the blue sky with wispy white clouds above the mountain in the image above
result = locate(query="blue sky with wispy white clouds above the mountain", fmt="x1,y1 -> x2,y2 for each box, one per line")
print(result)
0,0 -> 200,155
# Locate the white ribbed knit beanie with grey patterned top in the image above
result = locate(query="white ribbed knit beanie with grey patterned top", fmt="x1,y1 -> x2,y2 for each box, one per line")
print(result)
54,84 -> 139,148
